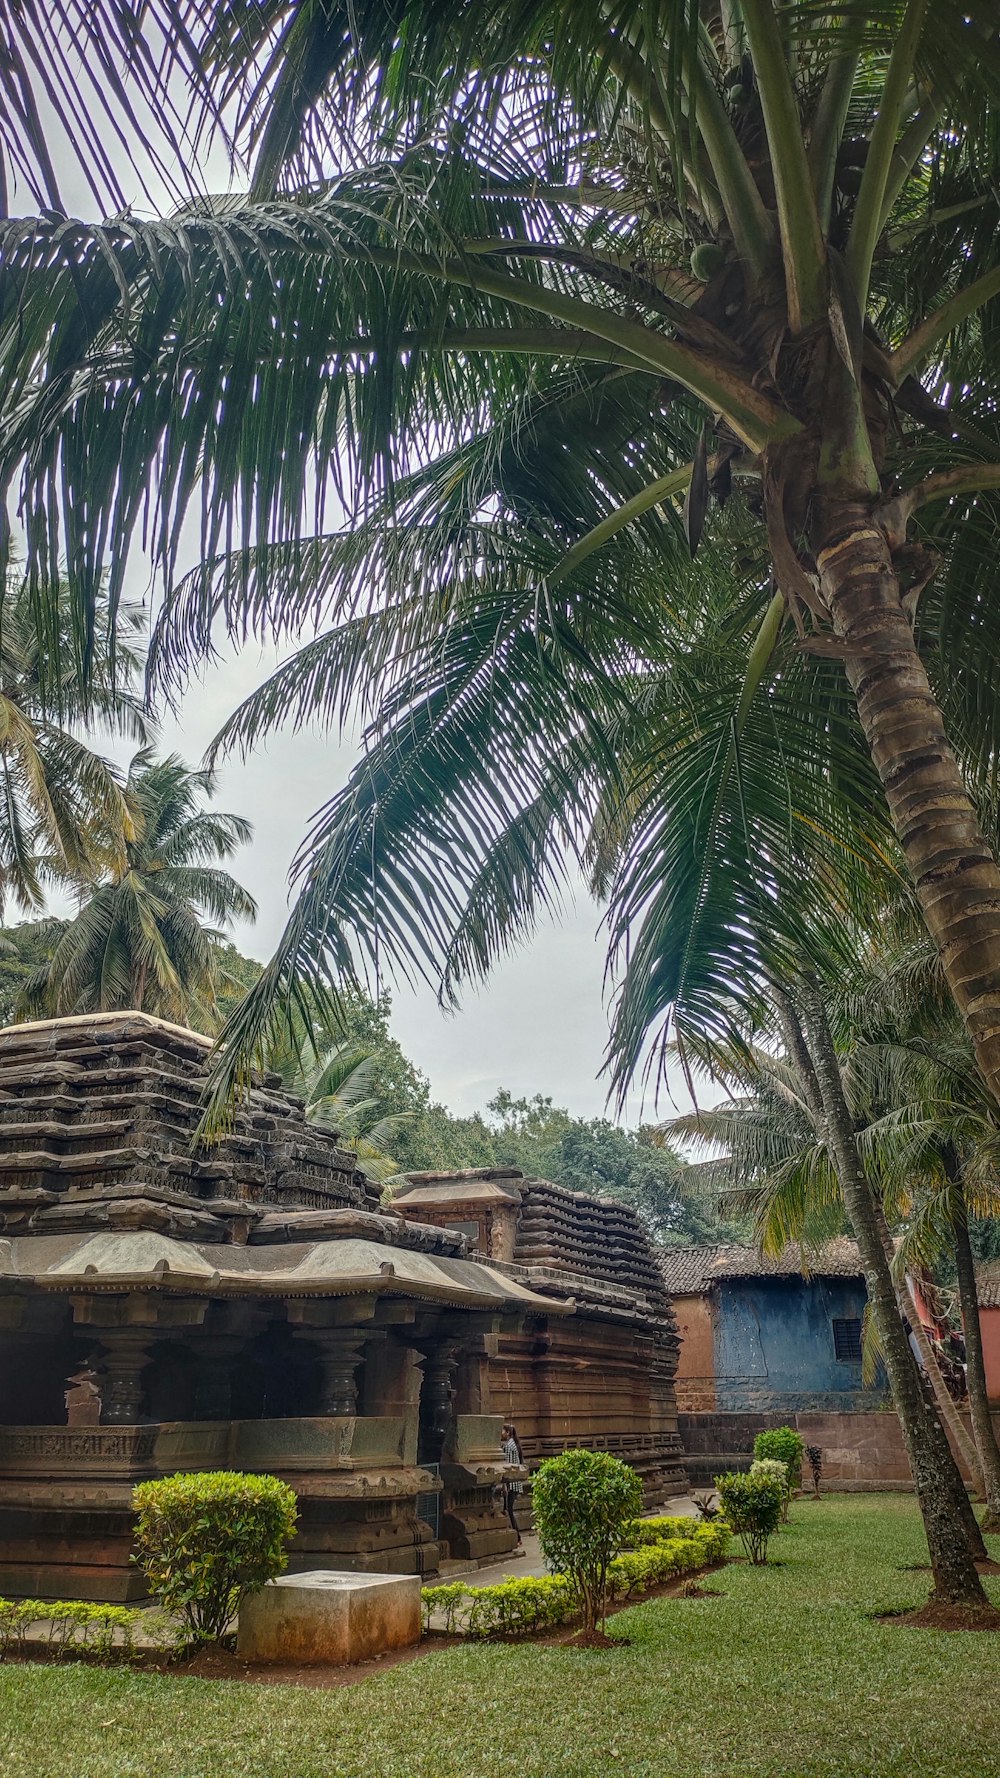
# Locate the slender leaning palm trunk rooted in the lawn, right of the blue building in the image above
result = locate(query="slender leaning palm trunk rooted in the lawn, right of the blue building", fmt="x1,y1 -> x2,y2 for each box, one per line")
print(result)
802,990 -> 989,1613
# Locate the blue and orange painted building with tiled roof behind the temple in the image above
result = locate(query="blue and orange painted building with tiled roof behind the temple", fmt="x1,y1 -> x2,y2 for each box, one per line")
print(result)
662,1239 -> 886,1414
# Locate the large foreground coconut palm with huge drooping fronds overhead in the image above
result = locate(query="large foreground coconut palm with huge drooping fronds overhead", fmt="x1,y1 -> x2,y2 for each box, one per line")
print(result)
0,0 -> 1000,1116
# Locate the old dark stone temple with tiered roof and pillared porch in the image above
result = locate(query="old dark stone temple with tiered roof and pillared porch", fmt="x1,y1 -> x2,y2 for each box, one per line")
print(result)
0,1013 -> 685,1600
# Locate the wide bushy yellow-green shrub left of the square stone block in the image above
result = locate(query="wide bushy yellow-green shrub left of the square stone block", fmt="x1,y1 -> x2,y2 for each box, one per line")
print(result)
132,1470 -> 297,1641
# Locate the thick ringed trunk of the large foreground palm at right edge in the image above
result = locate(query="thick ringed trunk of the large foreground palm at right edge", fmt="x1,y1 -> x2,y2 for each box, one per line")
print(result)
815,500 -> 1000,1101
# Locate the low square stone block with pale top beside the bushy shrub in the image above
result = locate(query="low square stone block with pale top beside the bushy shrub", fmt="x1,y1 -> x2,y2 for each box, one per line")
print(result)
237,1568 -> 420,1666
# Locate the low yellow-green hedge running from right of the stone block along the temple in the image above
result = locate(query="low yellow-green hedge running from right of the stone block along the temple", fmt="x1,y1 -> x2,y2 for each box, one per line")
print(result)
420,1518 -> 731,1641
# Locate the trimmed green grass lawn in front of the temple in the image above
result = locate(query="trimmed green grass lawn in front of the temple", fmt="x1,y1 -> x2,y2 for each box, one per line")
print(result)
0,1495 -> 1000,1778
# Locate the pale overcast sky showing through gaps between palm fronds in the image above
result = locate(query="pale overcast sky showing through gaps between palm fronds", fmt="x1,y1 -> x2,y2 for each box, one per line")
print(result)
33,62 -> 701,1122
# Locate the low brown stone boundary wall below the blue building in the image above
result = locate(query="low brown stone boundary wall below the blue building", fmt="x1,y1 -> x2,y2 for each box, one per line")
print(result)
678,1412 -> 1000,1492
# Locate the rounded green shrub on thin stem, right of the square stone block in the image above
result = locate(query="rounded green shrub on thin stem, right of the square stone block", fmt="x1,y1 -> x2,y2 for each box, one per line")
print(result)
532,1451 -> 642,1630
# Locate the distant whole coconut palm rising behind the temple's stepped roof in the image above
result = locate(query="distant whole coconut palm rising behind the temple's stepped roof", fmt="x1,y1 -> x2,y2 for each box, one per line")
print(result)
21,749 -> 256,1022
